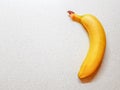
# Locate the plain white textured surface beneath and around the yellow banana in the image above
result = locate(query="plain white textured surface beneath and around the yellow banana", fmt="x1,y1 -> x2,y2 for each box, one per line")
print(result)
0,0 -> 120,90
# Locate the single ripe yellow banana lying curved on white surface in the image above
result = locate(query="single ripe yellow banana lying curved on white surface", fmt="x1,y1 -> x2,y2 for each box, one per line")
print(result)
68,11 -> 106,79
